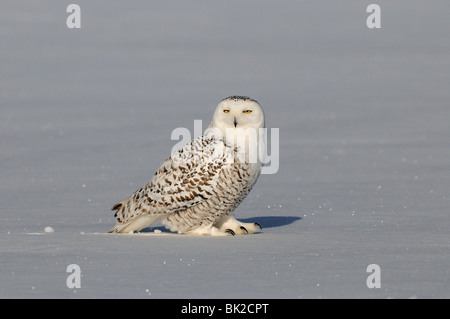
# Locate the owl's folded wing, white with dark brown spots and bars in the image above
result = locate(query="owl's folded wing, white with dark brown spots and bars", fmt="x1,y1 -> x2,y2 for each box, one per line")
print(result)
111,137 -> 233,232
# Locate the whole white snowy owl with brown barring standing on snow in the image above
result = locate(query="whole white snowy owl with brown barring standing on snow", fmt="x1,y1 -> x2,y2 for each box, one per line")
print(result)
110,96 -> 264,236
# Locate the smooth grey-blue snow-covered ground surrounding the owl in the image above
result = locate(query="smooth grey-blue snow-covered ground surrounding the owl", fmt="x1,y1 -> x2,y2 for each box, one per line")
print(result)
0,0 -> 450,298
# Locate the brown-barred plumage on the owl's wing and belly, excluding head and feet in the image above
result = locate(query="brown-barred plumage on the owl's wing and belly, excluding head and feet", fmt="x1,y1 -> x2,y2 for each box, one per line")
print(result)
110,136 -> 261,233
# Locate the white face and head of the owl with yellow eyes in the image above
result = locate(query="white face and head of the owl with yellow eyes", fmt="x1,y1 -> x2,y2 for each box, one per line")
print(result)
210,96 -> 264,130
